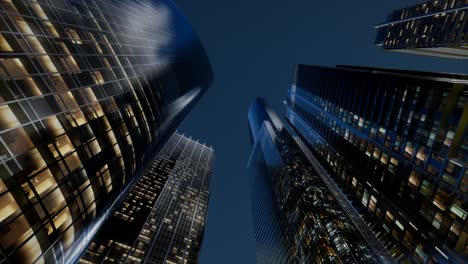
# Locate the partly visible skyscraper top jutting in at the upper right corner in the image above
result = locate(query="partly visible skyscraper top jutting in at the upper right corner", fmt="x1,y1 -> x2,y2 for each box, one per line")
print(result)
376,0 -> 468,59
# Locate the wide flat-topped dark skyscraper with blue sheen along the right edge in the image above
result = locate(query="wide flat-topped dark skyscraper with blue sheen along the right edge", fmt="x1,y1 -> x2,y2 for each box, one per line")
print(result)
287,65 -> 468,263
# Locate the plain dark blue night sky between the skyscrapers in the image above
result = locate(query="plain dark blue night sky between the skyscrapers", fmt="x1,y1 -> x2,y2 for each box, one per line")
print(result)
174,0 -> 468,264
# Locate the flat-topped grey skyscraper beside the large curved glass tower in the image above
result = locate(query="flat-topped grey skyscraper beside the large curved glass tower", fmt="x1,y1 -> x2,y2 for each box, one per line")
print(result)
79,133 -> 214,263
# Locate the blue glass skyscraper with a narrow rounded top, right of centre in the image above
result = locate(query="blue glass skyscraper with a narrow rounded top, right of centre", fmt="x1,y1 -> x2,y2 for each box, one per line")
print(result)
248,98 -> 393,263
